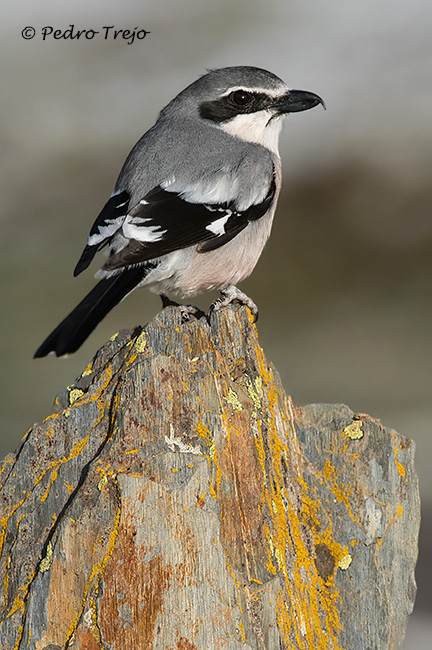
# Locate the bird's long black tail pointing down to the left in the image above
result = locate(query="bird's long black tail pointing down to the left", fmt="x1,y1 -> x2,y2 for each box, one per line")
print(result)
34,267 -> 148,359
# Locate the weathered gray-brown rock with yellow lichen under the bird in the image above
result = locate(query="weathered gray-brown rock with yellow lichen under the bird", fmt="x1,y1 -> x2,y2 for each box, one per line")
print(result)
0,306 -> 420,650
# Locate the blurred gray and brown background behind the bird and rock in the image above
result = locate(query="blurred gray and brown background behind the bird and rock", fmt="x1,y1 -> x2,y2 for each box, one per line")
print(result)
0,0 -> 432,636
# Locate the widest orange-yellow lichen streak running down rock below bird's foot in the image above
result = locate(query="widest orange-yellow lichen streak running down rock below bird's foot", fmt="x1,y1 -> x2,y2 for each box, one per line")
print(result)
250,345 -> 347,650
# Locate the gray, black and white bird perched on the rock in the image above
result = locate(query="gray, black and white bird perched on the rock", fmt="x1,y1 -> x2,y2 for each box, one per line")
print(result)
34,66 -> 325,358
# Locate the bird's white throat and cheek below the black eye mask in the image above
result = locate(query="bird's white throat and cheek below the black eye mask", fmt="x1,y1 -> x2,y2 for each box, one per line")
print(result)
221,111 -> 283,156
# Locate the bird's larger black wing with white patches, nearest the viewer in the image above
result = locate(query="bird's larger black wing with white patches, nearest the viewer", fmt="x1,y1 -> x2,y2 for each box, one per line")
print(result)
104,175 -> 276,270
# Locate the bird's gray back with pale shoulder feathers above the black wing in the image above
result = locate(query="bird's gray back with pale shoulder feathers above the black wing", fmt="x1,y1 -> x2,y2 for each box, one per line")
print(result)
116,116 -> 278,208
